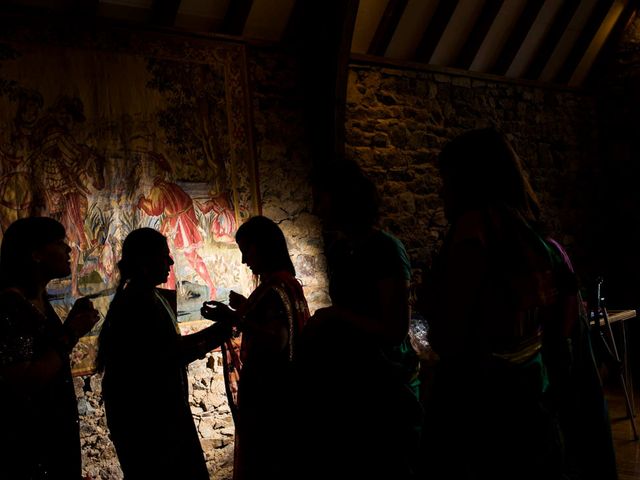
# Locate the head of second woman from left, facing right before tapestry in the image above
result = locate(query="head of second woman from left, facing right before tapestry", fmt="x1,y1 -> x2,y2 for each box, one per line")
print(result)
118,227 -> 173,287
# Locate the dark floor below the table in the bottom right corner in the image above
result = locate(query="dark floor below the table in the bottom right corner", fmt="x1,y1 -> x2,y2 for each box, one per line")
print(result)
607,387 -> 640,480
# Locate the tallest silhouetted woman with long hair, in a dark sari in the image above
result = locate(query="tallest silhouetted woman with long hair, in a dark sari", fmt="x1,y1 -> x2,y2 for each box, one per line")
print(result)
420,128 -> 575,480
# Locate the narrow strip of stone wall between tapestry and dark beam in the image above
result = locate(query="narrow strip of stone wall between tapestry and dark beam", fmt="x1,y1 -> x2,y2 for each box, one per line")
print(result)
249,49 -> 329,312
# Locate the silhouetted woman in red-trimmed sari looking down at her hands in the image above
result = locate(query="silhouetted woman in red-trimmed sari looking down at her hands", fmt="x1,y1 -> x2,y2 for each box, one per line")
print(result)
202,216 -> 309,480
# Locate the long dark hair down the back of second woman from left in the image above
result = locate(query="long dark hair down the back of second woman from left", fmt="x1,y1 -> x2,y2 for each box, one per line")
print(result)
96,227 -> 167,372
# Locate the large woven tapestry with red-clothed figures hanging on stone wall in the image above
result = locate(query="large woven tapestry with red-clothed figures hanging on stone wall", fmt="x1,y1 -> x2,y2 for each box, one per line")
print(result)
0,29 -> 259,375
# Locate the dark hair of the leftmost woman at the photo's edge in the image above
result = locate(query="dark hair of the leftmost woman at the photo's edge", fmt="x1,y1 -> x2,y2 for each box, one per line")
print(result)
0,217 -> 66,288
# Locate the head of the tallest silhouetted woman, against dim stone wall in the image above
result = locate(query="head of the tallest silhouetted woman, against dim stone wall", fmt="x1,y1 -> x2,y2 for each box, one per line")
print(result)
439,128 -> 539,221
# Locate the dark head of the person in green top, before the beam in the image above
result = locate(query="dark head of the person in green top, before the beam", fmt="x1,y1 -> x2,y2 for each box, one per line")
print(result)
311,160 -> 380,232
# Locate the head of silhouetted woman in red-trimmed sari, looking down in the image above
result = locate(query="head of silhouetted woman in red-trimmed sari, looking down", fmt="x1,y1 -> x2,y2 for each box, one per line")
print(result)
236,215 -> 296,276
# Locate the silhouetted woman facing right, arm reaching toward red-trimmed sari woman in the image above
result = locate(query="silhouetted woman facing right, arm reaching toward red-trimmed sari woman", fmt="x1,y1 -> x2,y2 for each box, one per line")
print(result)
98,228 -> 231,480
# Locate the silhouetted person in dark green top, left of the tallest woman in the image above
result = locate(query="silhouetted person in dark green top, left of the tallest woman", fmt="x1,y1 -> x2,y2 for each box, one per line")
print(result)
302,160 -> 421,479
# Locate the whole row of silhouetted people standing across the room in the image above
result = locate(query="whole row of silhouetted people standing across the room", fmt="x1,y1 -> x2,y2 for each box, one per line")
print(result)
0,128 -> 617,480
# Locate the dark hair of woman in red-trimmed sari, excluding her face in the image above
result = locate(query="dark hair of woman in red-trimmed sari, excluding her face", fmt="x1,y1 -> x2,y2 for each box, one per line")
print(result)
236,215 -> 296,277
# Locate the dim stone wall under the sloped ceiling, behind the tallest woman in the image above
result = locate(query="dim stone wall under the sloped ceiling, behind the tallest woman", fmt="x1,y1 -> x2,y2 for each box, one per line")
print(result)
347,63 -> 601,284
